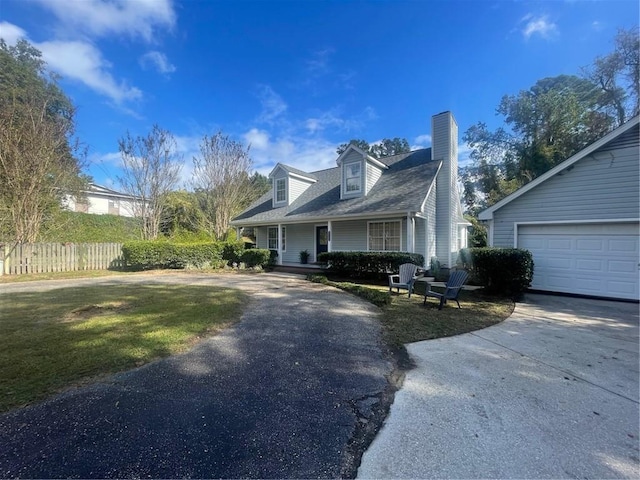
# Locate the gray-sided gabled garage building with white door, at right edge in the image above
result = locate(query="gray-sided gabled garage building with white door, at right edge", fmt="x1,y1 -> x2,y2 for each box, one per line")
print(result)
479,117 -> 640,300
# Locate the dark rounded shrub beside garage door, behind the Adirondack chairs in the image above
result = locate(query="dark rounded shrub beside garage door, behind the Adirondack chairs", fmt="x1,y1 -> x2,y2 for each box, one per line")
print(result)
458,247 -> 533,298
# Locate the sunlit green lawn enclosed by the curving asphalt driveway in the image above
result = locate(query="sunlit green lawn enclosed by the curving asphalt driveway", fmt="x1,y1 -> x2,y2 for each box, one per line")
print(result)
0,285 -> 245,412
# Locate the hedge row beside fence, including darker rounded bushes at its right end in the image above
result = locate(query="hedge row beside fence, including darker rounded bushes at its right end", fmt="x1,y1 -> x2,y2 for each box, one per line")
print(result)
122,241 -> 270,270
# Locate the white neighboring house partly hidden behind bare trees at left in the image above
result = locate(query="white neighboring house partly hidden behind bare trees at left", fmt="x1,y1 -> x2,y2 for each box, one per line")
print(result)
66,183 -> 140,217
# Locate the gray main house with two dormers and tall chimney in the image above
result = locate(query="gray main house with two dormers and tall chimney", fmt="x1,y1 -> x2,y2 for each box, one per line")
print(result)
231,112 -> 469,268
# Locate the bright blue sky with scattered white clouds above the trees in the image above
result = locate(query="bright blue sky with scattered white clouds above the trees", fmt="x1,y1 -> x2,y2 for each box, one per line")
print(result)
0,0 -> 640,188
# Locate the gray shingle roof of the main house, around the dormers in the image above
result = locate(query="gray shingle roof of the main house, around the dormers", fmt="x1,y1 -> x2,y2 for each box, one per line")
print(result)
232,148 -> 441,225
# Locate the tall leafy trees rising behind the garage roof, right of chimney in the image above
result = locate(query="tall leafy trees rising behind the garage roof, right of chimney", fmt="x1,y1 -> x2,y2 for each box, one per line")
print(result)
462,75 -> 615,211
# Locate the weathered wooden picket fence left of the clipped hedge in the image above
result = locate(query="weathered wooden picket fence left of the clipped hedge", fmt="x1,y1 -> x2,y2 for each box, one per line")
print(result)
0,243 -> 124,275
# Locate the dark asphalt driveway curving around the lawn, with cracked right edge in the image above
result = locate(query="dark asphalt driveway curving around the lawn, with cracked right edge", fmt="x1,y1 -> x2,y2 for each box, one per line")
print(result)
0,274 -> 393,478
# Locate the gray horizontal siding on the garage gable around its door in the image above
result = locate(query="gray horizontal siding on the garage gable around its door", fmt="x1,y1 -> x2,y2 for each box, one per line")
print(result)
493,143 -> 640,247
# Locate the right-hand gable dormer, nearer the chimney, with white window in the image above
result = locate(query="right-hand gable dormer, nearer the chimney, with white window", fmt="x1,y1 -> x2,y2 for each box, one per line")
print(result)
336,145 -> 389,199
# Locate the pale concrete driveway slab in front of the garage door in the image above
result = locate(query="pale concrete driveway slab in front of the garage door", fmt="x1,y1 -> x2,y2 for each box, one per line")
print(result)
358,295 -> 640,478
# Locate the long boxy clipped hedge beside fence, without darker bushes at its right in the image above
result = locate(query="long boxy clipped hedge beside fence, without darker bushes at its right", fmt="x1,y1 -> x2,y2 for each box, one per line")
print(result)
122,240 -> 223,270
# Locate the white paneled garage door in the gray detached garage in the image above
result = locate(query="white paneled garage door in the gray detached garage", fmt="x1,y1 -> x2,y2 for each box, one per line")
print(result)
518,223 -> 640,300
